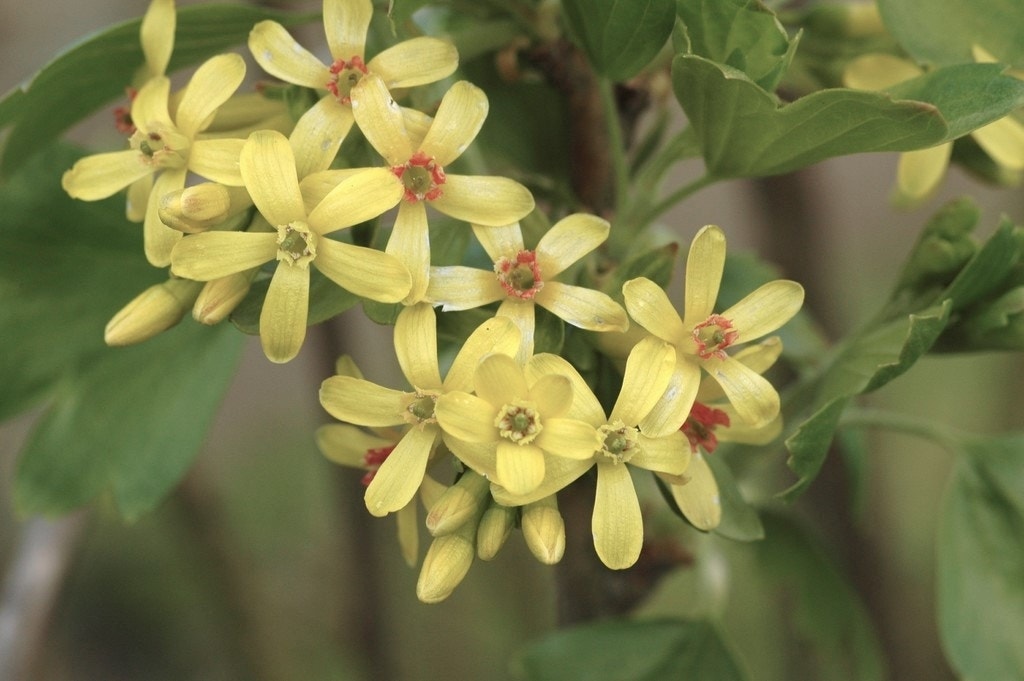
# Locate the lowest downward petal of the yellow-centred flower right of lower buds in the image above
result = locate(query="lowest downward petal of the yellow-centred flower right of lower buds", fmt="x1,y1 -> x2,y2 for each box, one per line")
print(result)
591,463 -> 643,569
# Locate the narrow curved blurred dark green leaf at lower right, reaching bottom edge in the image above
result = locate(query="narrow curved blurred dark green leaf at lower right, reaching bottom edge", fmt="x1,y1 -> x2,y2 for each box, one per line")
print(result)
756,513 -> 886,681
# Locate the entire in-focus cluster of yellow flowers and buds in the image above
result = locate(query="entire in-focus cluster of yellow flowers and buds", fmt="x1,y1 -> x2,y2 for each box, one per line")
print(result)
63,0 -> 803,602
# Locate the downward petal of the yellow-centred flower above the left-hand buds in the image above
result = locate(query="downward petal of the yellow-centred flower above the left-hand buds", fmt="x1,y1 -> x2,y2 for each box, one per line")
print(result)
259,262 -> 309,364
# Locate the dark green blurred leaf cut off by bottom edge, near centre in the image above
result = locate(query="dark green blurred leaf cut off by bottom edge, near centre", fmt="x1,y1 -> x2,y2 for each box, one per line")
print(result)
513,620 -> 748,681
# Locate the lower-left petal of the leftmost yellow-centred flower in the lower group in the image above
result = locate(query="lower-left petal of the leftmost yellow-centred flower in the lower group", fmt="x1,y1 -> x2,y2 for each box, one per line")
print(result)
365,425 -> 441,516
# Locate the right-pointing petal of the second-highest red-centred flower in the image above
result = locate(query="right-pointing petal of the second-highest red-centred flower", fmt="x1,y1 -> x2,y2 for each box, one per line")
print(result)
430,175 -> 535,226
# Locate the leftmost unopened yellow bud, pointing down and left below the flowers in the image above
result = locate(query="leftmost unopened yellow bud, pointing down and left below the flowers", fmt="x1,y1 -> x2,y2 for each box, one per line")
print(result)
103,279 -> 203,345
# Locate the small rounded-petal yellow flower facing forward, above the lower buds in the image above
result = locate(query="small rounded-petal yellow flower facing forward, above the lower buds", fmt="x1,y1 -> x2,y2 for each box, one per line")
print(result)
435,352 -> 601,496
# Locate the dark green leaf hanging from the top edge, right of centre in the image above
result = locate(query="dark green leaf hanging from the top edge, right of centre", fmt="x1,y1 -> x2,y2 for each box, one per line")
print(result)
562,0 -> 676,81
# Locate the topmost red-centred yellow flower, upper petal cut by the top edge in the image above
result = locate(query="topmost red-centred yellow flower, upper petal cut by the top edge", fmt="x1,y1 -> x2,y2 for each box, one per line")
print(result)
249,0 -> 459,176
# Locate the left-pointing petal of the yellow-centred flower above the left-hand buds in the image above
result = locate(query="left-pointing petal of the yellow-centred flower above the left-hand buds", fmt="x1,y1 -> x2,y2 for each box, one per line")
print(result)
171,231 -> 278,282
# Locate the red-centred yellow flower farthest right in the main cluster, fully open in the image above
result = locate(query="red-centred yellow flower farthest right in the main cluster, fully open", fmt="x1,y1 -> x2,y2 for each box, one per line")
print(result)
623,225 -> 804,427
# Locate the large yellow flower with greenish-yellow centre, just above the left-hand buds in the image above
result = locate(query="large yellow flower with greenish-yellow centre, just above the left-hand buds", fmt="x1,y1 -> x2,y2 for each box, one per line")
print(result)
171,130 -> 410,363
